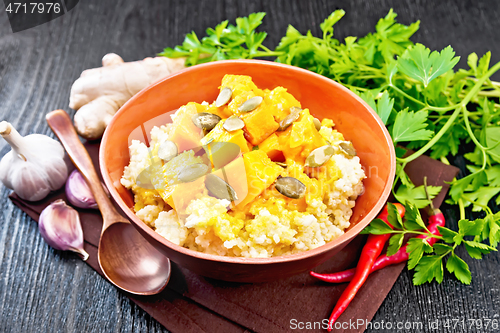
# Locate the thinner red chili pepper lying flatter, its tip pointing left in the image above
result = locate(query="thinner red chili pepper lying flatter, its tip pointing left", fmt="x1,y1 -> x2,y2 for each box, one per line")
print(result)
310,209 -> 445,283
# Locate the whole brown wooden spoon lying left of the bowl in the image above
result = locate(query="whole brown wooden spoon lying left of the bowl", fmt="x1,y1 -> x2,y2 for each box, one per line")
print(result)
46,110 -> 171,295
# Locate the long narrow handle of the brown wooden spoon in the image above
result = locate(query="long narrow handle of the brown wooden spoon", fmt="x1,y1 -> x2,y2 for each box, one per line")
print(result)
46,110 -> 124,226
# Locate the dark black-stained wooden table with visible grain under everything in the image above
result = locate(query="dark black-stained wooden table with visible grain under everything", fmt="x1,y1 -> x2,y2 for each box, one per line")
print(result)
0,0 -> 500,332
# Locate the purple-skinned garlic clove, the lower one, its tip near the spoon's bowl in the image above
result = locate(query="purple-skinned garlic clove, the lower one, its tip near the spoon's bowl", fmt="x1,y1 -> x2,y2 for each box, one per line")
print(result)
38,199 -> 89,261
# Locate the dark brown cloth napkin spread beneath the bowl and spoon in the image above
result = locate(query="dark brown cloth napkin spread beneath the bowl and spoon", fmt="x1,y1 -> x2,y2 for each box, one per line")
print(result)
10,143 -> 458,332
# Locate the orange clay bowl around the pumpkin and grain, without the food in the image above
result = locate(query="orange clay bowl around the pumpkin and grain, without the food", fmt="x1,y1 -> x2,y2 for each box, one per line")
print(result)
99,60 -> 396,282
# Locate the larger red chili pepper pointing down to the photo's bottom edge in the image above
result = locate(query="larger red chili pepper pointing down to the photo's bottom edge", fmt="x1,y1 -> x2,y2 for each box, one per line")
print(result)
328,204 -> 405,331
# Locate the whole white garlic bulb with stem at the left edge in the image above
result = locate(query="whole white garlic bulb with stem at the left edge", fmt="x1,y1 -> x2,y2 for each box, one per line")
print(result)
0,121 -> 68,201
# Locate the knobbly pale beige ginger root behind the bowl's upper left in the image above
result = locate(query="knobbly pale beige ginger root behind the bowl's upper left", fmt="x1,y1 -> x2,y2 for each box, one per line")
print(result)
69,53 -> 185,140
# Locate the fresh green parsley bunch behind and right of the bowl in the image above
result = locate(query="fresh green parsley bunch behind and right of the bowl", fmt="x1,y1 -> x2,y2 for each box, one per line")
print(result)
161,9 -> 500,283
